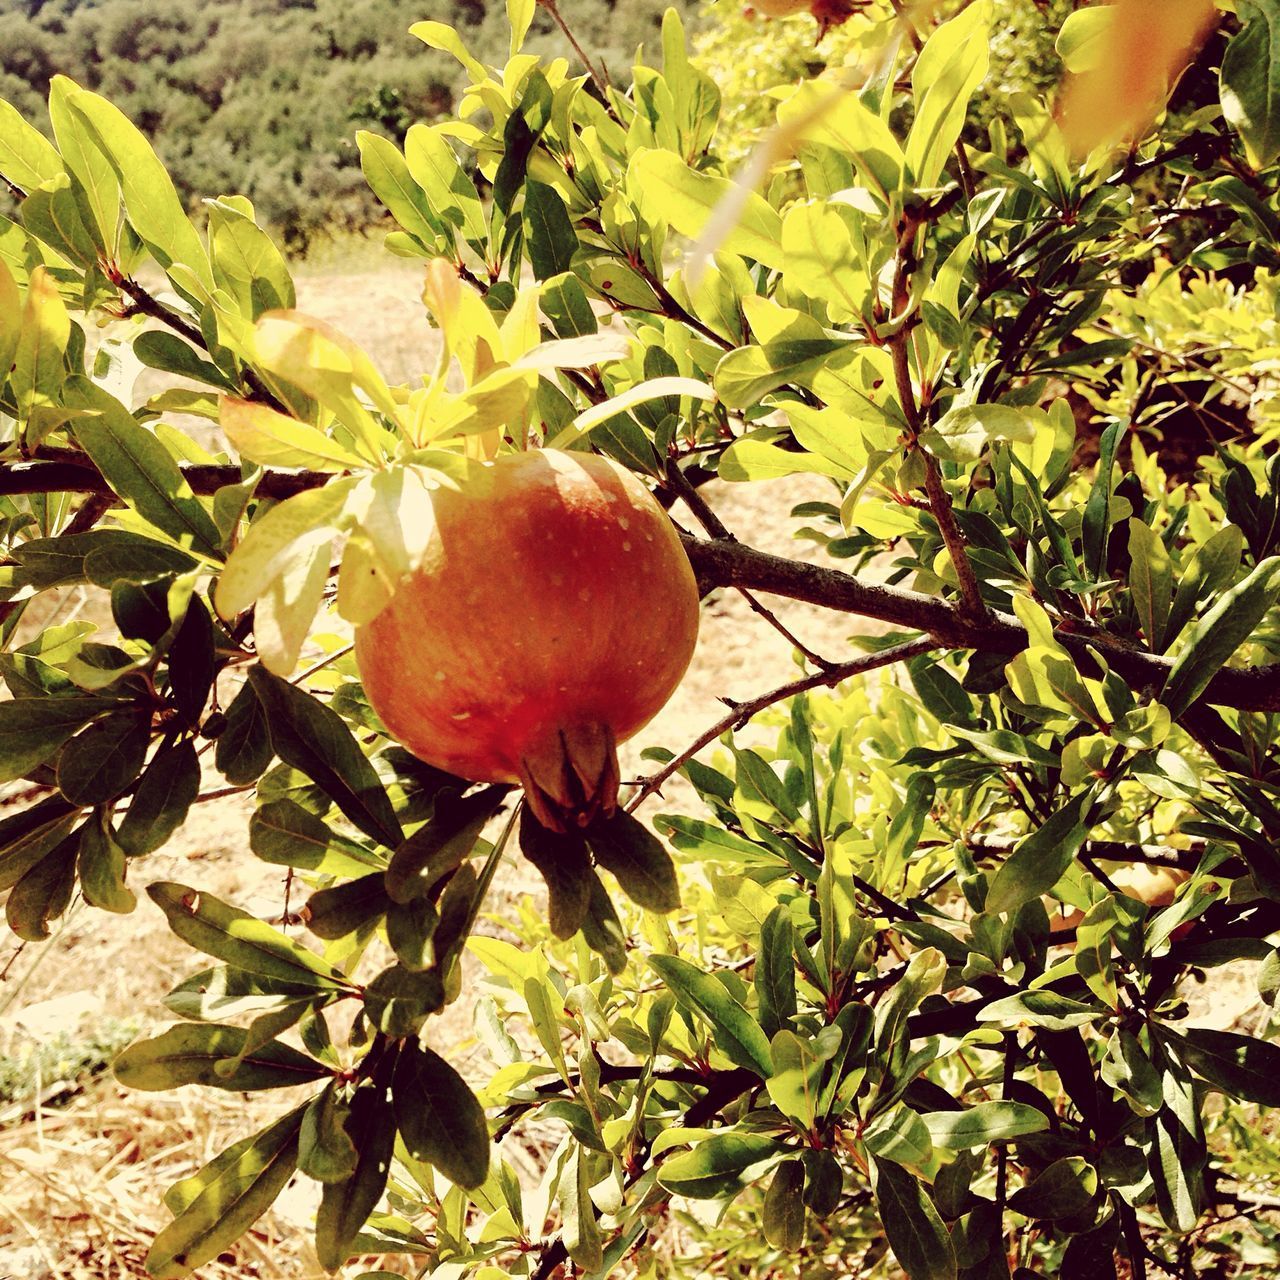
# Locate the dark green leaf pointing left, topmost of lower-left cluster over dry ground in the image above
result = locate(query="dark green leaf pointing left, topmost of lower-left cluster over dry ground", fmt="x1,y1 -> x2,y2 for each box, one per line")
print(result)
147,881 -> 351,991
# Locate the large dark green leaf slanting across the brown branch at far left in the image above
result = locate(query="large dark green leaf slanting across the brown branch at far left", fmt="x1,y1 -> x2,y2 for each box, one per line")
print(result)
63,378 -> 221,556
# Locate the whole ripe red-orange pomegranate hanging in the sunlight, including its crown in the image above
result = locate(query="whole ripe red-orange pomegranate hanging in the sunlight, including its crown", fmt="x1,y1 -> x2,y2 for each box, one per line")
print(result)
356,449 -> 698,831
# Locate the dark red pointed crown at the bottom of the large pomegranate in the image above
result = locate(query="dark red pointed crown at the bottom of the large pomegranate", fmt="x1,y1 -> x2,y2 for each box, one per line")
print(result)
520,722 -> 620,833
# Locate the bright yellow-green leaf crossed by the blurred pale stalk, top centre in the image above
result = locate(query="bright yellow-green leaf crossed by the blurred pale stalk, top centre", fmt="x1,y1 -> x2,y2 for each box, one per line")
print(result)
627,151 -> 786,270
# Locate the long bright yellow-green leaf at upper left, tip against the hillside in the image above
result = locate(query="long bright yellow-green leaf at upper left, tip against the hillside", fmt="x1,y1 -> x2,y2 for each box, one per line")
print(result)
67,90 -> 214,289
